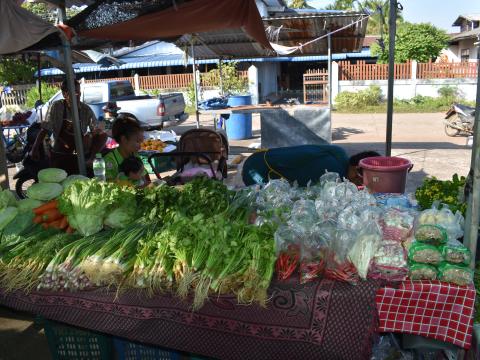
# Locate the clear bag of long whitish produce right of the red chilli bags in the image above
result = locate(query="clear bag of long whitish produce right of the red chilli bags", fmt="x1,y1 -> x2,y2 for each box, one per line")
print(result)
348,221 -> 382,280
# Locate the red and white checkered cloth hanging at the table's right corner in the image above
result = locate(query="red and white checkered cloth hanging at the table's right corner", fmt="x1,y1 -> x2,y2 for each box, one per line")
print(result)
376,281 -> 475,349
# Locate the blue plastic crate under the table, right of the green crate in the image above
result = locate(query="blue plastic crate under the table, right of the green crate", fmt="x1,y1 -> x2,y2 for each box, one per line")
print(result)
113,338 -> 180,360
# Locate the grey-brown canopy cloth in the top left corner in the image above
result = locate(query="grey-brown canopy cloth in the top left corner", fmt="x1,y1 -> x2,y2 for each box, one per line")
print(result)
0,0 -> 59,54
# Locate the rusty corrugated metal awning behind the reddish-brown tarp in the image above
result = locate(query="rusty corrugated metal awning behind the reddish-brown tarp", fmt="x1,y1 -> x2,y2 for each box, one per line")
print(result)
175,9 -> 368,59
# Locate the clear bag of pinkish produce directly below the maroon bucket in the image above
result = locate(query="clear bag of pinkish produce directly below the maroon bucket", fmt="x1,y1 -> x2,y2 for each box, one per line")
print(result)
380,207 -> 415,241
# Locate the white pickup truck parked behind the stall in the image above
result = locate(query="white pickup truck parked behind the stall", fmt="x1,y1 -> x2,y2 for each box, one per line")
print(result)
41,81 -> 188,129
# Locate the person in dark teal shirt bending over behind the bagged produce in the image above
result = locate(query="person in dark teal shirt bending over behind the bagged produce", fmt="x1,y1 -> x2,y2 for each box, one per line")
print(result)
242,144 -> 380,186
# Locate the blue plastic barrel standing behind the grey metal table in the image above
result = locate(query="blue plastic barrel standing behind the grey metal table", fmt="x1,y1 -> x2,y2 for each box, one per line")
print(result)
225,95 -> 252,140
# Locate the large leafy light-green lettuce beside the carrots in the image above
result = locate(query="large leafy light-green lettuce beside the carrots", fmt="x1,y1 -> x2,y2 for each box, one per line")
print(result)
59,179 -> 136,236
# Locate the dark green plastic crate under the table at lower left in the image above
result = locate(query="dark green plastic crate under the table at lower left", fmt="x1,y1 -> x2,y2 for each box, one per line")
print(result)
42,319 -> 112,360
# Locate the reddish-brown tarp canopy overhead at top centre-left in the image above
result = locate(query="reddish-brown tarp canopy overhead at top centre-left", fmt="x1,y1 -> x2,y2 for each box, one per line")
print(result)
68,0 -> 273,52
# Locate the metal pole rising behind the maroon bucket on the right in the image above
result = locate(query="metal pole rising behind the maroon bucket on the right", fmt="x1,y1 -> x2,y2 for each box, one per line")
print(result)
385,0 -> 397,156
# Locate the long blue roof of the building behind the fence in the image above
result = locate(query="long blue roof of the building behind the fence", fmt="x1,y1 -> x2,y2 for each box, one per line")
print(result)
37,42 -> 372,76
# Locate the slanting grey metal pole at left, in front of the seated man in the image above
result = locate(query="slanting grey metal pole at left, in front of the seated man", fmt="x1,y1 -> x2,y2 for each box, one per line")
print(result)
58,2 -> 87,176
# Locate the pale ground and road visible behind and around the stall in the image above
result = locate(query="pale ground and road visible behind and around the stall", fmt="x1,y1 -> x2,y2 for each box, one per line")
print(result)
0,113 -> 471,360
